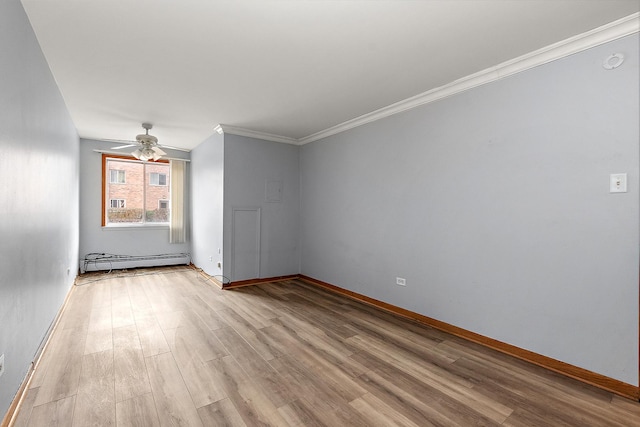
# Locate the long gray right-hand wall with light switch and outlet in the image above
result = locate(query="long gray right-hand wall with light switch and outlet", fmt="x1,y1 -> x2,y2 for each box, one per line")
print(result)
300,35 -> 640,385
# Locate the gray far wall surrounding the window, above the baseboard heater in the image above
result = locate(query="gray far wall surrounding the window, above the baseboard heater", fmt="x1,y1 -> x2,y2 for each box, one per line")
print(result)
78,139 -> 191,265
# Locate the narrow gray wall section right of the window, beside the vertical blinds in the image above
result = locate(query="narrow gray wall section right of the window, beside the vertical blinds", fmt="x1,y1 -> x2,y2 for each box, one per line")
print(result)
191,133 -> 224,279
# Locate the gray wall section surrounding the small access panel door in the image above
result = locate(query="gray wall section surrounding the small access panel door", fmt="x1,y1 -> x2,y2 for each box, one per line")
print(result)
223,134 -> 300,280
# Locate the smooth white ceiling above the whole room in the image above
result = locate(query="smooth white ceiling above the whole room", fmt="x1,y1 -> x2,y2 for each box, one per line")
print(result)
22,0 -> 640,149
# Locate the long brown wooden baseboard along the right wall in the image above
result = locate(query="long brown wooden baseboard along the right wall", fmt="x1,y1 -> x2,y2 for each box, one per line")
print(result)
299,275 -> 640,401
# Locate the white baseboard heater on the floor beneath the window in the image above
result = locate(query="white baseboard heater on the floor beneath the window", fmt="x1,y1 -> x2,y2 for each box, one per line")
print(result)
80,252 -> 191,273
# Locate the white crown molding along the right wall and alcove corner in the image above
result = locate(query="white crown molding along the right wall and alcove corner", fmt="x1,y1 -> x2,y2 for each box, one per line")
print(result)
216,13 -> 640,145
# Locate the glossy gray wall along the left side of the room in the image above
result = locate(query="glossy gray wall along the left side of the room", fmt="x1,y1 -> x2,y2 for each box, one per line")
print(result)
0,0 -> 78,418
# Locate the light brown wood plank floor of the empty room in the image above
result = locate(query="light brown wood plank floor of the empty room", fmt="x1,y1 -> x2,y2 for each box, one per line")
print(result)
14,268 -> 640,427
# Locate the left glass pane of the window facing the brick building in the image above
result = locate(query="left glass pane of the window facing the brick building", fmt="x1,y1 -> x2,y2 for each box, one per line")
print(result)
106,159 -> 144,224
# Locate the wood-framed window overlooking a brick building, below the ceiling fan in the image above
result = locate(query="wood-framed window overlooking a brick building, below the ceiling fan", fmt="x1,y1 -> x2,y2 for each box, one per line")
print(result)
102,154 -> 171,226
